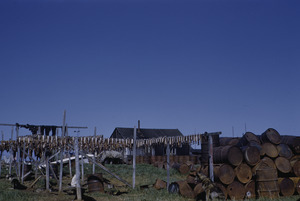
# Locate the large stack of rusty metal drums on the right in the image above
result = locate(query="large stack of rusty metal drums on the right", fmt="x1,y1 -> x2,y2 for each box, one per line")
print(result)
200,128 -> 300,200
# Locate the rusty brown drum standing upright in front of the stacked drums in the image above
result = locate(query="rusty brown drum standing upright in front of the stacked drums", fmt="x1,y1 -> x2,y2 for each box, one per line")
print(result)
256,167 -> 279,198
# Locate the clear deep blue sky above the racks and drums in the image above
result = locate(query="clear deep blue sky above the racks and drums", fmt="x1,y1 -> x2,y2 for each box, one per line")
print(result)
0,0 -> 300,139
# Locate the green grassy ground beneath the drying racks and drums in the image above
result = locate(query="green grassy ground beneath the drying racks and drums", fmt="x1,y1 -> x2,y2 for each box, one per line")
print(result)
0,164 -> 300,201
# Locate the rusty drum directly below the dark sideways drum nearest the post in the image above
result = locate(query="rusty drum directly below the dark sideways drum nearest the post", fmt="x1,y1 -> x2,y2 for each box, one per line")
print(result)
214,163 -> 235,185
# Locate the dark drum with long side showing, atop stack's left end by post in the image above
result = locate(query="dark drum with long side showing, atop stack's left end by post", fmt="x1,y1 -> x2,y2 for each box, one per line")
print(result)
213,146 -> 243,166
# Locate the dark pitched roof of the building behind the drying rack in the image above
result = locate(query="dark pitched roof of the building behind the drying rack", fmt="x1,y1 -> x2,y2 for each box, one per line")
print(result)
110,127 -> 183,139
